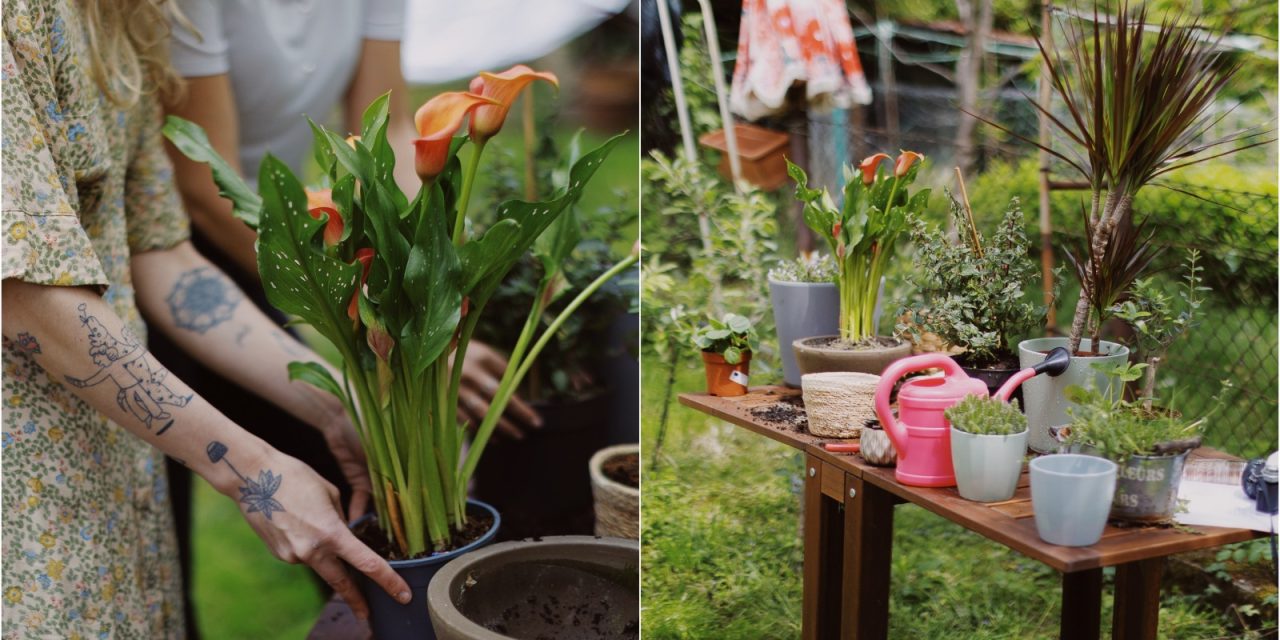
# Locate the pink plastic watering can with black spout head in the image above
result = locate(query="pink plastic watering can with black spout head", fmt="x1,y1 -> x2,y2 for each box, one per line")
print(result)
876,347 -> 1071,486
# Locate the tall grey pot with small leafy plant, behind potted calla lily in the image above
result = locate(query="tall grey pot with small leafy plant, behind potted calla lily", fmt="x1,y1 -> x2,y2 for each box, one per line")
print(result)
769,253 -> 840,387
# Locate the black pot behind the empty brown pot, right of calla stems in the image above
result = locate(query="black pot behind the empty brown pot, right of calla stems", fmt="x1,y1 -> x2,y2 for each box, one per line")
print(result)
474,390 -> 612,541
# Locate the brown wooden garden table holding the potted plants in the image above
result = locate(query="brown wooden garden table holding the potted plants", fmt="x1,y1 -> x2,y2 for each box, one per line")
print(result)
680,387 -> 1262,640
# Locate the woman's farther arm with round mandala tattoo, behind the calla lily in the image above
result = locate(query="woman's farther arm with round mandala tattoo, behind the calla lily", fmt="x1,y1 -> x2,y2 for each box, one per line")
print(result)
132,242 -> 371,518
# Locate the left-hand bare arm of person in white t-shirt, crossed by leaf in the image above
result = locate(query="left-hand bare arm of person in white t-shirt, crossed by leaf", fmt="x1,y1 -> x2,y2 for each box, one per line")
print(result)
165,73 -> 261,279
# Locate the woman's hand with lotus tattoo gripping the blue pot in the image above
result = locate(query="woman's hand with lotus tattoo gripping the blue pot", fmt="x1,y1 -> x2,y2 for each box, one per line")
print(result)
227,443 -> 412,620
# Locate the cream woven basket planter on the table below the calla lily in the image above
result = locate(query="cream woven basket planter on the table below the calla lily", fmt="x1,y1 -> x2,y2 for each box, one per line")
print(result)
800,371 -> 879,438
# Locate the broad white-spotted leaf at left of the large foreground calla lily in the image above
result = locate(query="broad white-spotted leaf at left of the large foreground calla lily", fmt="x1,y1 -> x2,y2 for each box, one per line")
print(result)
257,154 -> 360,344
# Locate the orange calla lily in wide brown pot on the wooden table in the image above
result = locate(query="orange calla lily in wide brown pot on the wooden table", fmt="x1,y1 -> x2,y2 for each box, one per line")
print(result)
787,151 -> 929,375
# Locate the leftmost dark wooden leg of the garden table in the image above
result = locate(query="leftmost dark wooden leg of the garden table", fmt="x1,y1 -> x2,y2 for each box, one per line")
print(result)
800,456 -> 844,640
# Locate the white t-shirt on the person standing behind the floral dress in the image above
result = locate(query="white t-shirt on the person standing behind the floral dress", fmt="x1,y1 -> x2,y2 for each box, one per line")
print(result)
172,0 -> 404,182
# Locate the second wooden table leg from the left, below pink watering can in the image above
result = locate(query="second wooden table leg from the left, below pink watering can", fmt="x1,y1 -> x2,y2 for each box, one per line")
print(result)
842,474 -> 899,640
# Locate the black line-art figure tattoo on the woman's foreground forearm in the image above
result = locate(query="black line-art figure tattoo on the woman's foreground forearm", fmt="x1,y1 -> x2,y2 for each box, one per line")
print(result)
67,302 -> 192,435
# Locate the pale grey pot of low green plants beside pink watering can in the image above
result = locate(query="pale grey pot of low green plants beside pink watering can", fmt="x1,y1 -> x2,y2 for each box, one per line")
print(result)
945,396 -> 1027,502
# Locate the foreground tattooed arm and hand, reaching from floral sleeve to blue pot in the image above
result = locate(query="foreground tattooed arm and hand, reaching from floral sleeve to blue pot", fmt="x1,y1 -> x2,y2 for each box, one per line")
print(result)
0,279 -> 411,617
